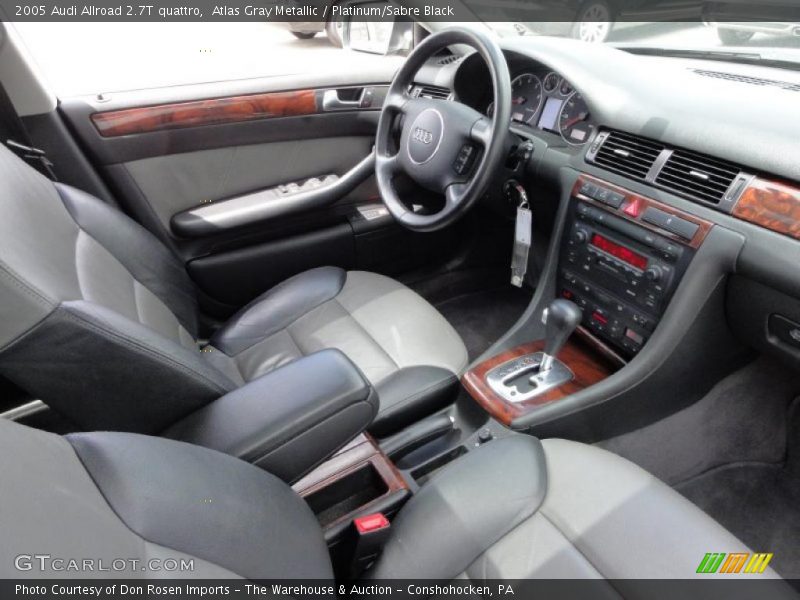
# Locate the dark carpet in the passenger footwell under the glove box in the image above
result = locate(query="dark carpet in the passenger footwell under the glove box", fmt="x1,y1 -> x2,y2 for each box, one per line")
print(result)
600,358 -> 800,579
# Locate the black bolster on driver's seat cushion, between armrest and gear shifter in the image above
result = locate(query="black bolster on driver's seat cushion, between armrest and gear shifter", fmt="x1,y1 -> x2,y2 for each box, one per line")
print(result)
369,366 -> 459,437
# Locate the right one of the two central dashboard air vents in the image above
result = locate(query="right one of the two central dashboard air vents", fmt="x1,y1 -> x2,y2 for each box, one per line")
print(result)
655,150 -> 741,205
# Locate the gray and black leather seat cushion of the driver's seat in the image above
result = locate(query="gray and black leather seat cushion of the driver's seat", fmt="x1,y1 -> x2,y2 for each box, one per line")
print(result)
211,267 -> 467,435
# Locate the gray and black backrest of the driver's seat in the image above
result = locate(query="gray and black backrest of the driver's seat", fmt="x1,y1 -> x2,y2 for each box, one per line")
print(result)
0,147 -> 236,432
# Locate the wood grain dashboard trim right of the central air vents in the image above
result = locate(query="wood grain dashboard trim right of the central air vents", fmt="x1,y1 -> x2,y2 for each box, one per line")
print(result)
733,177 -> 800,239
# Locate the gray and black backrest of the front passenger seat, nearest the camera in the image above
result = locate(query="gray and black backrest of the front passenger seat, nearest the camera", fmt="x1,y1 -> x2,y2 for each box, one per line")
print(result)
0,420 -> 332,579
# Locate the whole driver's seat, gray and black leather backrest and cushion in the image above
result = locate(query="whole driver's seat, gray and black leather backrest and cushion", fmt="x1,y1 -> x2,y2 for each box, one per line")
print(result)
0,147 -> 467,436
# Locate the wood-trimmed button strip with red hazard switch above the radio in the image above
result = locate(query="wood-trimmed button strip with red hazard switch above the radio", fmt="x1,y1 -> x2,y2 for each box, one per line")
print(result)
572,175 -> 714,250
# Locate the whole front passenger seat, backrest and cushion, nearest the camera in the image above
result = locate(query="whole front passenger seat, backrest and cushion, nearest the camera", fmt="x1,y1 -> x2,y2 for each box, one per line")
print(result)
0,421 -> 783,584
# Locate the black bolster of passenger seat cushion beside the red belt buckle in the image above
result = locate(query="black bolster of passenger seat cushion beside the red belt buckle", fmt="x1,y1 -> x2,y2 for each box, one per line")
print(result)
367,435 -> 547,581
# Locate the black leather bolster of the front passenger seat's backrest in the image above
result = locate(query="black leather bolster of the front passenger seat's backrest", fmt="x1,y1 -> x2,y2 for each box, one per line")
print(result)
67,433 -> 333,579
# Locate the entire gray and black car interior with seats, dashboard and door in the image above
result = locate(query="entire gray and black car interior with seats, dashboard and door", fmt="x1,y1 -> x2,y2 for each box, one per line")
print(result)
0,8 -> 800,597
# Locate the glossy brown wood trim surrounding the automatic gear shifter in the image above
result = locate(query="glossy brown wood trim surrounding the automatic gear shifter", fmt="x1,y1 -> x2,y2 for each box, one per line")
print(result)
461,337 -> 620,425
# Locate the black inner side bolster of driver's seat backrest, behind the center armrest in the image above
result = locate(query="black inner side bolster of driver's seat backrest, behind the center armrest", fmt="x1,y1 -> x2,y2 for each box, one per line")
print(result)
0,300 -> 235,434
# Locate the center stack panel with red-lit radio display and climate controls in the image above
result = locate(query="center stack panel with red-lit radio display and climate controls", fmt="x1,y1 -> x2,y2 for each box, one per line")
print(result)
558,179 -> 700,358
